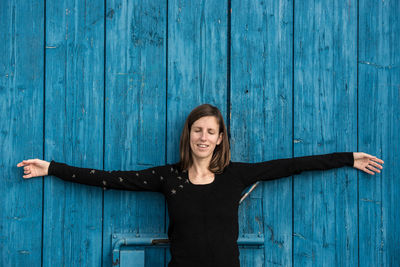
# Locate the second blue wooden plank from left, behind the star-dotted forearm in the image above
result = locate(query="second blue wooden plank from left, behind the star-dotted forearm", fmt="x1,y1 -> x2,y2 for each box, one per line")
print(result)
43,0 -> 104,266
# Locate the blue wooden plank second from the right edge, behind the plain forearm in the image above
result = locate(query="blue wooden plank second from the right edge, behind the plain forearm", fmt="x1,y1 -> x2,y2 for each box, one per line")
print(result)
293,1 -> 357,266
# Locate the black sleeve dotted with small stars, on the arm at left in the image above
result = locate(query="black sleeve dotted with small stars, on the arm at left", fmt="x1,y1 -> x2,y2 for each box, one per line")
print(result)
48,160 -> 165,192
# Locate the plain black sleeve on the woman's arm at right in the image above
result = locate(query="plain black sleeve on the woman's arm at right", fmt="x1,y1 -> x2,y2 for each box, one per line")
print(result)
235,152 -> 354,187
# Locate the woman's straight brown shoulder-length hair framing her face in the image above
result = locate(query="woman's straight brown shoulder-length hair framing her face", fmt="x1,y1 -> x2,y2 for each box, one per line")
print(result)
178,104 -> 231,173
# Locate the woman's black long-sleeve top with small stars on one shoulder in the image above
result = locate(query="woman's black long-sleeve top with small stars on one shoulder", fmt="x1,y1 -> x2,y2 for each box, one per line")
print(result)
48,152 -> 354,267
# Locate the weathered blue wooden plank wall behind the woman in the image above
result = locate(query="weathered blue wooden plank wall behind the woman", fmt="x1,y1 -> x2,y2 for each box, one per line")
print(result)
0,0 -> 400,267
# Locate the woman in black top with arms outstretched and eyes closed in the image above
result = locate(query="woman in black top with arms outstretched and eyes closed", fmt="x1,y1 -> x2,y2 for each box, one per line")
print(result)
17,104 -> 383,267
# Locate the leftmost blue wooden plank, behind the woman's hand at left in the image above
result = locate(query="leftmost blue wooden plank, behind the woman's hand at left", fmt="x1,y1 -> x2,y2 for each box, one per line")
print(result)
0,1 -> 44,266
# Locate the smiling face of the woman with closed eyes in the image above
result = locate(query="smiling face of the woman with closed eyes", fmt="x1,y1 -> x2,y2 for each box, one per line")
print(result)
190,116 -> 222,159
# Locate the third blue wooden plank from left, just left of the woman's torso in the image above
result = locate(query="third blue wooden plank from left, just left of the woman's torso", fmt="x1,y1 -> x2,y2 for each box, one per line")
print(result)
103,0 -> 167,266
